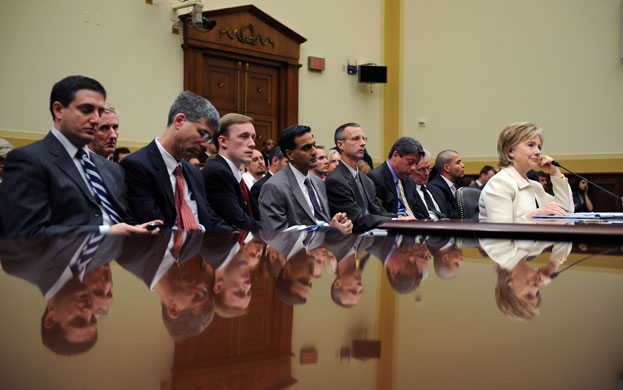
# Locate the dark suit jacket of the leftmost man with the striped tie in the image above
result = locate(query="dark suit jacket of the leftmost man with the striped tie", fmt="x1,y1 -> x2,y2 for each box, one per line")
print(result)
0,133 -> 134,236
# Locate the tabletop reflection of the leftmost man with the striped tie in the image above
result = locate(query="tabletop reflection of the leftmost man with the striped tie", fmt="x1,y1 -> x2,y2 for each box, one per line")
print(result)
0,235 -> 123,355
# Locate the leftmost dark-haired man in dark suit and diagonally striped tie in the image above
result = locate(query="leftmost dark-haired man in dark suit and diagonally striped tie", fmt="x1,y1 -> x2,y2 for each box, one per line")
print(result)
0,76 -> 161,236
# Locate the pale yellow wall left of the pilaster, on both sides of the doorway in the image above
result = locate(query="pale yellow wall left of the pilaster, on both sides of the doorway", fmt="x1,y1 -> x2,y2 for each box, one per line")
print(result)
0,0 -> 383,157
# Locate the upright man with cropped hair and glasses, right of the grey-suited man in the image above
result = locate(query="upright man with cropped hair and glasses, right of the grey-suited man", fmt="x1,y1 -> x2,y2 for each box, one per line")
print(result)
325,123 -> 413,233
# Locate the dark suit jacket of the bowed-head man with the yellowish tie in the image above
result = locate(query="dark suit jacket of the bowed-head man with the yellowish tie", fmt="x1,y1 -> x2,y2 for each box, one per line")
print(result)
368,161 -> 429,219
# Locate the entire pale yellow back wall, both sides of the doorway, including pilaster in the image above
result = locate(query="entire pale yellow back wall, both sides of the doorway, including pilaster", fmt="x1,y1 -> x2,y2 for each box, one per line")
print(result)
0,0 -> 623,163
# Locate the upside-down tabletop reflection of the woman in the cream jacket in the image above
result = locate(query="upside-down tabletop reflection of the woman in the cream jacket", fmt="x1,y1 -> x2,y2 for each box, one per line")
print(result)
480,239 -> 572,320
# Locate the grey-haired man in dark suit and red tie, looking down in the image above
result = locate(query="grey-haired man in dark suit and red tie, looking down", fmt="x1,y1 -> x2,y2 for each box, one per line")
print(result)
121,91 -> 228,231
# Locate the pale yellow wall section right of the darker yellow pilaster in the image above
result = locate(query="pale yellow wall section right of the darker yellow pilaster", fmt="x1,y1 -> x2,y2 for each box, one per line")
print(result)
402,0 -> 623,165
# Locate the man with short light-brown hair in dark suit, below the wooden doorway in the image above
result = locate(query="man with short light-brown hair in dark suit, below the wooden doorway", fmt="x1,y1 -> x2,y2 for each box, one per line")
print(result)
202,114 -> 263,230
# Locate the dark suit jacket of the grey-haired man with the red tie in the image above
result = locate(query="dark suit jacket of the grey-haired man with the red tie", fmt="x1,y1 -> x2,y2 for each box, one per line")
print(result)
121,141 -> 229,230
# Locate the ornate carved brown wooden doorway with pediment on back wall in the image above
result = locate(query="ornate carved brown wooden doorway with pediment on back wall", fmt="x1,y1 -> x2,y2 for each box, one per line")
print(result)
183,5 -> 305,147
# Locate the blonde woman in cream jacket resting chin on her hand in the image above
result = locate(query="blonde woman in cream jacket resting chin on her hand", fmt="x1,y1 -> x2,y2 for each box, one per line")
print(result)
479,122 -> 573,222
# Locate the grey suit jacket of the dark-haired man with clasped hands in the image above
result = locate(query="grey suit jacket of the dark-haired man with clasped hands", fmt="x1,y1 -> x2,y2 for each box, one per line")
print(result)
259,164 -> 331,230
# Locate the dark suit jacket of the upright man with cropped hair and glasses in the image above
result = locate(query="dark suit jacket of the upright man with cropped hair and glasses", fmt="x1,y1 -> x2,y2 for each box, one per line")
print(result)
325,162 -> 397,233
